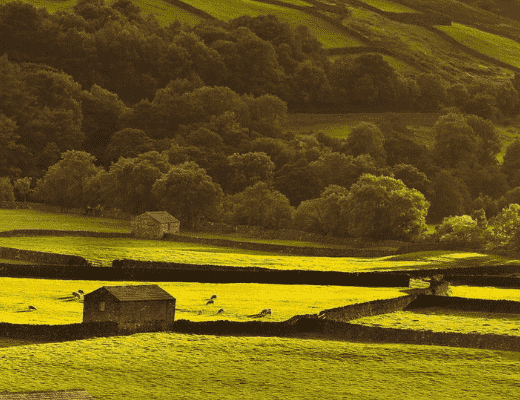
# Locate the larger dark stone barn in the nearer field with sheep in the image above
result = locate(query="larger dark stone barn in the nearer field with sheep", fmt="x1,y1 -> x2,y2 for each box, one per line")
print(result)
83,285 -> 176,334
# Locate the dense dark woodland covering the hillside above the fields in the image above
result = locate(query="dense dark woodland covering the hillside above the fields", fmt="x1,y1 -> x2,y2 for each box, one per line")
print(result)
0,0 -> 520,246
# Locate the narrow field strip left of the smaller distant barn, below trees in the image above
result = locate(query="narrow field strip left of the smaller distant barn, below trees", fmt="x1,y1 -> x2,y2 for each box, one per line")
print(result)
0,210 -> 130,232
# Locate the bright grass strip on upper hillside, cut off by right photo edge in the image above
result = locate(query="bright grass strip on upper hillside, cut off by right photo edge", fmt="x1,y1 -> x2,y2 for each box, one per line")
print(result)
437,23 -> 520,67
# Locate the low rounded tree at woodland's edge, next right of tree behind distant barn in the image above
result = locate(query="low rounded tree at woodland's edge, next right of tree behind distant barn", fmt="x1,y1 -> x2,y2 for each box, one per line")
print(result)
226,182 -> 293,229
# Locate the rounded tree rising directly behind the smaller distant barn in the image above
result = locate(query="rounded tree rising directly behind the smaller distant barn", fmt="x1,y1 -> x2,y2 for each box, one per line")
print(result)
152,162 -> 223,229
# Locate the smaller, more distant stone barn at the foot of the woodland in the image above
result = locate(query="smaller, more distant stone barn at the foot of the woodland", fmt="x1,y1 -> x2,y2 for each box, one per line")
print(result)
131,211 -> 181,239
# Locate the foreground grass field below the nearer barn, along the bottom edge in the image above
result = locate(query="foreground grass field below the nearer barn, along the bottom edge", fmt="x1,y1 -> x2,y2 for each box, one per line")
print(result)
0,333 -> 520,400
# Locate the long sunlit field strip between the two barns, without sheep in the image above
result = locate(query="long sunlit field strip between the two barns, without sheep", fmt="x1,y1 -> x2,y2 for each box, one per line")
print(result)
0,236 -> 507,272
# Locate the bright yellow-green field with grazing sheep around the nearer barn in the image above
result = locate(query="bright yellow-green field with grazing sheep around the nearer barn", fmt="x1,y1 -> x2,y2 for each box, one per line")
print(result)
0,278 -> 405,325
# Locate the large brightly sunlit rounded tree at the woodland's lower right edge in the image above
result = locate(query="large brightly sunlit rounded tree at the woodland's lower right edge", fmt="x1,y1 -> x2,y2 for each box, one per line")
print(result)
347,174 -> 430,240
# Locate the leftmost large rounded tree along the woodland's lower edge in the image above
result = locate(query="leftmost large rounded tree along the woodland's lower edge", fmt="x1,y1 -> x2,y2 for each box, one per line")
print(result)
35,150 -> 99,207
